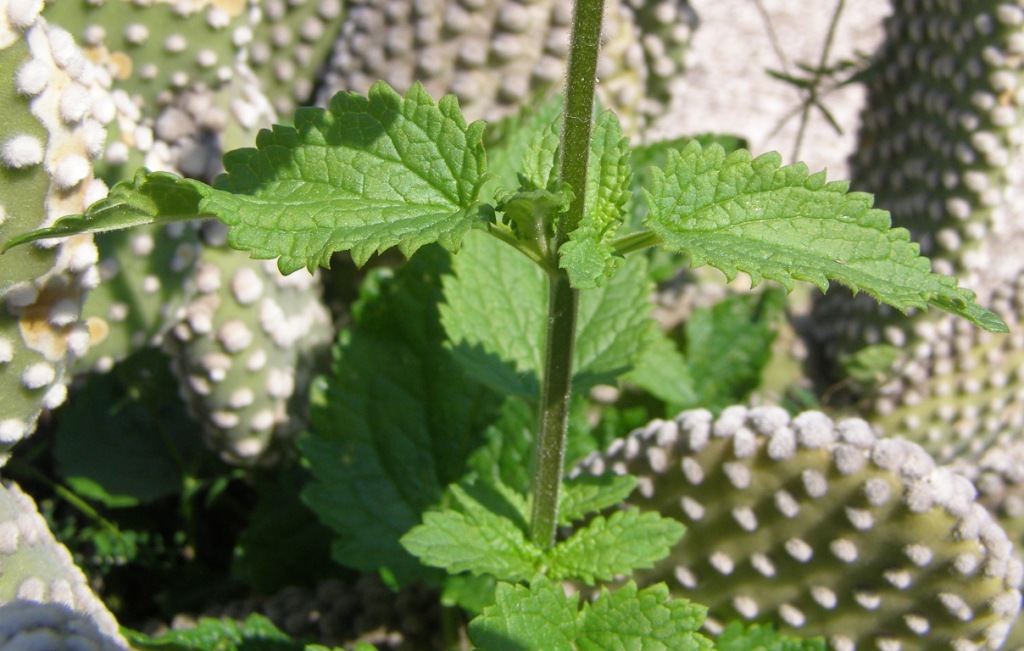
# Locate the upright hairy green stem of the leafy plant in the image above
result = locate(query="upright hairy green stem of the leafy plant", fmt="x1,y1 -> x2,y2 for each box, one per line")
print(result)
529,0 -> 604,547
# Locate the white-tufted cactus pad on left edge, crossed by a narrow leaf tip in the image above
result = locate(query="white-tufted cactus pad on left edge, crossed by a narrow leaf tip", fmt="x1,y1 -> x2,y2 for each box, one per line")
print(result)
0,0 -> 106,454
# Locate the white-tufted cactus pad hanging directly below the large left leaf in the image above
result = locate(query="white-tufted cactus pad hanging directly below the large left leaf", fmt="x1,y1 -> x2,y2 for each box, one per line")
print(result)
166,223 -> 333,464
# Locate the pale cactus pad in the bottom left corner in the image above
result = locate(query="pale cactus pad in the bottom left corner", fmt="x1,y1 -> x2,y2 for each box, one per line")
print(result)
0,482 -> 127,649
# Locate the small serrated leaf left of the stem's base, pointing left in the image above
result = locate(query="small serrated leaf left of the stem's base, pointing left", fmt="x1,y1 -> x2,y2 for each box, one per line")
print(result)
400,484 -> 542,581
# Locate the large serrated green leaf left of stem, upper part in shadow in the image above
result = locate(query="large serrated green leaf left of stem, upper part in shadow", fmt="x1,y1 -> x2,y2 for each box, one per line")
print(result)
201,83 -> 486,273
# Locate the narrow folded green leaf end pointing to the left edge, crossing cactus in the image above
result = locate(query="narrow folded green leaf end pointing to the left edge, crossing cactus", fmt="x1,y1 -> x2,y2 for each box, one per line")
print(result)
0,168 -> 214,253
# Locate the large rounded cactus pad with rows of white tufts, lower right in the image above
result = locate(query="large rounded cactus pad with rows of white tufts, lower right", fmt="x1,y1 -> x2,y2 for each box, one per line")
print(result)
579,406 -> 1022,651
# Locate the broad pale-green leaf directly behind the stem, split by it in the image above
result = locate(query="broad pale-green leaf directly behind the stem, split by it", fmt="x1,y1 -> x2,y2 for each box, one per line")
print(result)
440,233 -> 652,400
